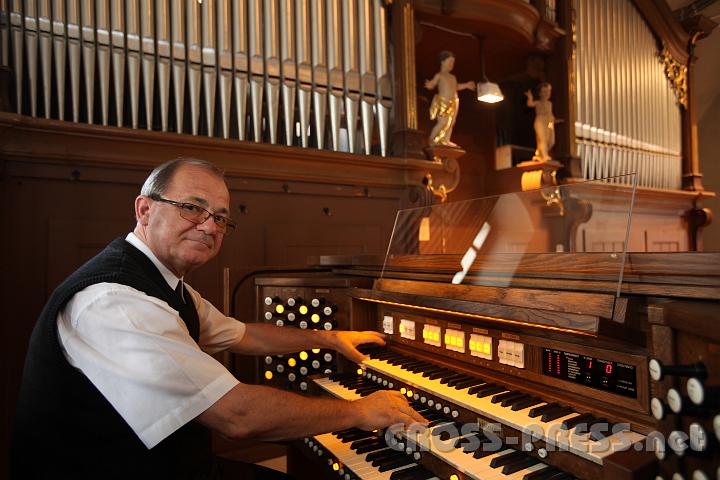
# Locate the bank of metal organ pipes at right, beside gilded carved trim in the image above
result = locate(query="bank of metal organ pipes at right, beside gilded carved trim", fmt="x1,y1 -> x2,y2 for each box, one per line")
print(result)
575,0 -> 682,189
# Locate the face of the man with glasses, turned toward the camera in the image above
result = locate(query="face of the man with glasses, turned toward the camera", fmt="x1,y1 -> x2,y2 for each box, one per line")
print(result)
138,165 -> 230,277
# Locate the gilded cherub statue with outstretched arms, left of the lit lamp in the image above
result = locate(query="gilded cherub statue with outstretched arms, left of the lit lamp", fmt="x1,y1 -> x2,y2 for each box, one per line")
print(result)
425,50 -> 475,147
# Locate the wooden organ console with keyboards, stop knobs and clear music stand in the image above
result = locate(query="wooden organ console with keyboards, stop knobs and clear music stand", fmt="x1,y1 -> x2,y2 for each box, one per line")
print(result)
272,184 -> 720,480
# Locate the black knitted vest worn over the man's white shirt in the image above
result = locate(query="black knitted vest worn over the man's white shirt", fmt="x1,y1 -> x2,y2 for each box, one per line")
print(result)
11,238 -> 212,479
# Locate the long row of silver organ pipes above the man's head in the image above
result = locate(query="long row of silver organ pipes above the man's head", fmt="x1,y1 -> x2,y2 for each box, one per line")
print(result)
0,0 -> 392,155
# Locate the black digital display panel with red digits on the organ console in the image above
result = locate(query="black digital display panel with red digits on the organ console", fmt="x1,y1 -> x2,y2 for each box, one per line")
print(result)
543,348 -> 637,398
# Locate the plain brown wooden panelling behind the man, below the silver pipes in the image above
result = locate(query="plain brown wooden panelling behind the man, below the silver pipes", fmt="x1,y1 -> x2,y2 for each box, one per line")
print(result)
0,114 -> 443,478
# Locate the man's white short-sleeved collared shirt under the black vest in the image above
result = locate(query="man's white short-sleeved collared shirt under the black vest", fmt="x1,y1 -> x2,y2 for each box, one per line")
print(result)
57,233 -> 245,448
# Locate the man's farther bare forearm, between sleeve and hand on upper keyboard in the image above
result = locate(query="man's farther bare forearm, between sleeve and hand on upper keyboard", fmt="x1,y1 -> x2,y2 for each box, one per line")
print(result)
230,323 -> 336,355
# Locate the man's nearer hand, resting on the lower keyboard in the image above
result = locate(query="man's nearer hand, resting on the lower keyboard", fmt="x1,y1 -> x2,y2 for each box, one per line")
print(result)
353,390 -> 428,431
